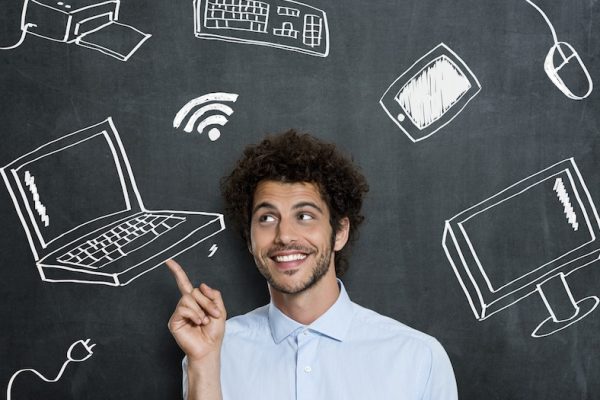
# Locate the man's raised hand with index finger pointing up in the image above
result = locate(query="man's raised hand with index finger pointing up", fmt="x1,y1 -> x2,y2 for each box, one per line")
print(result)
166,260 -> 227,364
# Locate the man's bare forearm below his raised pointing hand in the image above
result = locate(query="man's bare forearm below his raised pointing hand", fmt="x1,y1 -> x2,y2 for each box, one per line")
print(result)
187,355 -> 223,400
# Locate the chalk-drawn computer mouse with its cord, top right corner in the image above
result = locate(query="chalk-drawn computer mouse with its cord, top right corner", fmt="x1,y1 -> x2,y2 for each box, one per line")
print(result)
525,0 -> 594,100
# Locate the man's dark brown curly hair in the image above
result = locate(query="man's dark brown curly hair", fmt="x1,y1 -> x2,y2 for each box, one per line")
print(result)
221,129 -> 369,276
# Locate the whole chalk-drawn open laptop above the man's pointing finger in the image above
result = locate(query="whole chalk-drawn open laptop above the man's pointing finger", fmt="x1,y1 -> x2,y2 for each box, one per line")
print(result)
1,118 -> 225,286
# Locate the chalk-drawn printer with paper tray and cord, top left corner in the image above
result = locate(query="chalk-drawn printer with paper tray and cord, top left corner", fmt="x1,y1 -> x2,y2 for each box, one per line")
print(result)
0,0 -> 152,61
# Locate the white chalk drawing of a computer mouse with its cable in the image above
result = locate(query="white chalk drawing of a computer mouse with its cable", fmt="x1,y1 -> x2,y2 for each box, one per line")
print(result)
525,0 -> 594,100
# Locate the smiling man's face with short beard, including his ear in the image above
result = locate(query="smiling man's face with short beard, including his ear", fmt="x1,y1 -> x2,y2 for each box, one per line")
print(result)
250,181 -> 349,294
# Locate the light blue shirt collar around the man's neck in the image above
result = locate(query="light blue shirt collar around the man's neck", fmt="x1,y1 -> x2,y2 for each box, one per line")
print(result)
269,279 -> 354,343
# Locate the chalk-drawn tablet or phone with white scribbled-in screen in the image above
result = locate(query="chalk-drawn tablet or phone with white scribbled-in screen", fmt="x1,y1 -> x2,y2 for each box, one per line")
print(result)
379,43 -> 481,142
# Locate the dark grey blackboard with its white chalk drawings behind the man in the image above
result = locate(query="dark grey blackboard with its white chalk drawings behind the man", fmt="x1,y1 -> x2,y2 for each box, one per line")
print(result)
0,0 -> 600,399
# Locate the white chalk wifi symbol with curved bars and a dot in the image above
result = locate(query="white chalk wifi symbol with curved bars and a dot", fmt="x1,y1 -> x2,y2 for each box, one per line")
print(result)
173,92 -> 238,142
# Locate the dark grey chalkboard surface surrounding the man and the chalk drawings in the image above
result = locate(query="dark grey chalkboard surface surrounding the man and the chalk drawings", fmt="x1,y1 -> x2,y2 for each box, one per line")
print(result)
0,0 -> 600,400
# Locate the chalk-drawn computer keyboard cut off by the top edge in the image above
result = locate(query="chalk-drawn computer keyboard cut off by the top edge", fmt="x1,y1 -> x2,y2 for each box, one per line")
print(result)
194,0 -> 329,57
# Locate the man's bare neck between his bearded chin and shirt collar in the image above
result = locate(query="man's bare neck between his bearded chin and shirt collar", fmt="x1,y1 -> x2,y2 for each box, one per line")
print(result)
269,268 -> 340,325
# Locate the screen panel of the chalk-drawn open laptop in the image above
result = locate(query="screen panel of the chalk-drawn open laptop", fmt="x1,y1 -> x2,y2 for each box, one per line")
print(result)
15,132 -> 130,247
